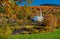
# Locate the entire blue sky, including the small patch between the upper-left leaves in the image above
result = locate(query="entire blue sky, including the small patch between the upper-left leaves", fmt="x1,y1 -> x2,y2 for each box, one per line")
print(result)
11,0 -> 60,6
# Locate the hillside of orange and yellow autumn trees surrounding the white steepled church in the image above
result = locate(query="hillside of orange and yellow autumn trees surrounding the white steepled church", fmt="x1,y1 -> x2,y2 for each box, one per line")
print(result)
0,3 -> 60,35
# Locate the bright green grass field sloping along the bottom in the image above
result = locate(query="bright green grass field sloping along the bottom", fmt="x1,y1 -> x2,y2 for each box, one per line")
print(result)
0,29 -> 60,39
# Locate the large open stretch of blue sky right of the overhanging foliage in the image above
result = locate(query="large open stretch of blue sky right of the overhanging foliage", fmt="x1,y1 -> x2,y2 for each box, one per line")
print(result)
31,0 -> 60,6
